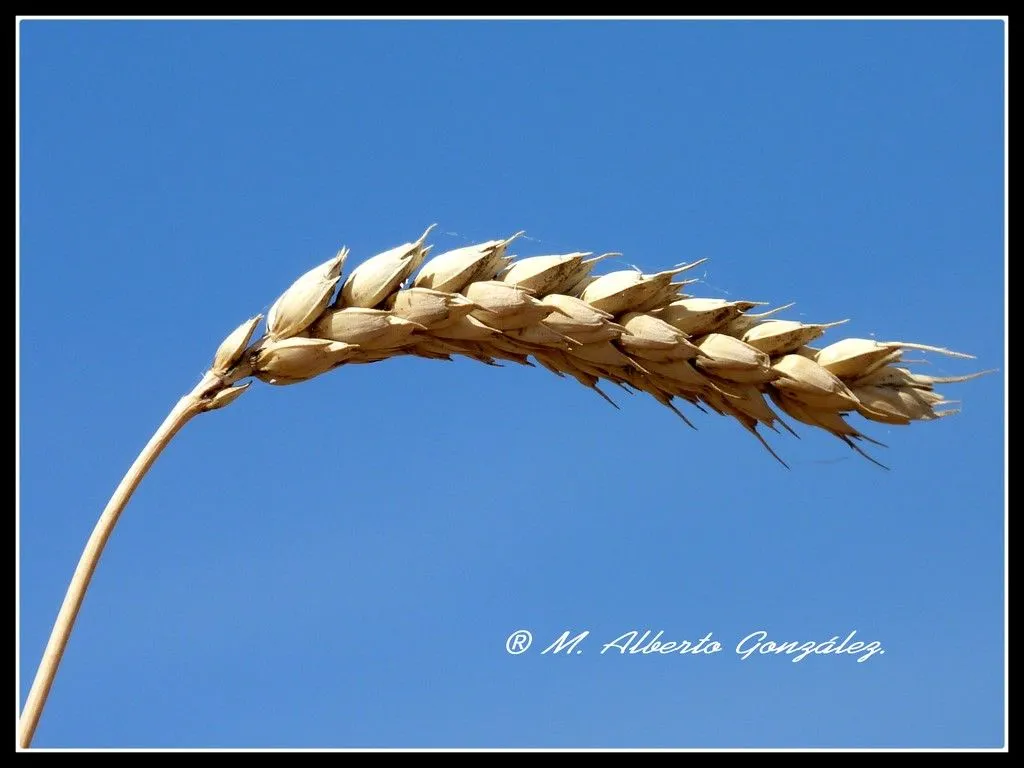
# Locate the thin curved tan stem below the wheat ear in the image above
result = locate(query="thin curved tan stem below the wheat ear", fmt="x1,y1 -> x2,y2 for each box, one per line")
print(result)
18,374 -> 224,749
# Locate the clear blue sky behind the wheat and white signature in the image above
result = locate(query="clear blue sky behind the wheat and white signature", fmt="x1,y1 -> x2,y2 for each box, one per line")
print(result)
18,22 -> 1006,748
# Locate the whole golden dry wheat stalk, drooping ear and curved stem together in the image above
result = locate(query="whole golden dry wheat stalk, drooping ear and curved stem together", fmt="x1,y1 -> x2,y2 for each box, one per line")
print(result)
19,227 -> 988,748
